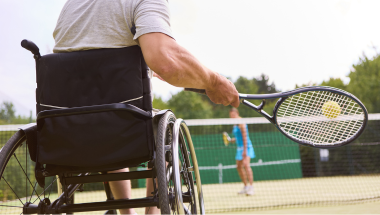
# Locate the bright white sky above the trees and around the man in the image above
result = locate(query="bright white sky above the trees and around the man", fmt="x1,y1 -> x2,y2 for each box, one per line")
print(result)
0,0 -> 380,116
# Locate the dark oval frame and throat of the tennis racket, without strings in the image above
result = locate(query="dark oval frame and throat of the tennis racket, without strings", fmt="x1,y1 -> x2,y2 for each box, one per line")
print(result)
239,86 -> 368,148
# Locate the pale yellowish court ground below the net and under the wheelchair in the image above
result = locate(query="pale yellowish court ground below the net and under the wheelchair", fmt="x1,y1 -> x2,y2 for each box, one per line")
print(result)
0,175 -> 380,214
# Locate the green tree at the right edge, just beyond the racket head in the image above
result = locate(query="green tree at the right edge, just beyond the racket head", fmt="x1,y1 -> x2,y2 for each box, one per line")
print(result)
347,55 -> 380,113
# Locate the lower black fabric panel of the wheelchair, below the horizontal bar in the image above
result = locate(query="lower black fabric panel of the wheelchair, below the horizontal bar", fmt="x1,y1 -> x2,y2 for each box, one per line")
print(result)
37,104 -> 154,167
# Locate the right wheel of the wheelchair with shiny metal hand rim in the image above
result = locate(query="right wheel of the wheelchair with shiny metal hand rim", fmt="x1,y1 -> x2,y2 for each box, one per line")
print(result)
156,112 -> 204,214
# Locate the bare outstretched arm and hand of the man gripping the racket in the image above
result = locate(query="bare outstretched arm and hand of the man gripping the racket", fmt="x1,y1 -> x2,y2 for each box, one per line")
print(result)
138,33 -> 239,107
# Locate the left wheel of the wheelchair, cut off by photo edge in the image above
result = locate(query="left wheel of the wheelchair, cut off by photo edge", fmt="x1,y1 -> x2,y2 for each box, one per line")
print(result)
0,131 -> 57,214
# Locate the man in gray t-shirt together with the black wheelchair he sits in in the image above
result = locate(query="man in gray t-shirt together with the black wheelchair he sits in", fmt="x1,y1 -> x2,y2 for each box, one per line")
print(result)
0,0 -> 239,214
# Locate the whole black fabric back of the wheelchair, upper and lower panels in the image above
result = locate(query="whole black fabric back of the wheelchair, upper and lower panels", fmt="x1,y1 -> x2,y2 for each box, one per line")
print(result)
29,46 -> 154,174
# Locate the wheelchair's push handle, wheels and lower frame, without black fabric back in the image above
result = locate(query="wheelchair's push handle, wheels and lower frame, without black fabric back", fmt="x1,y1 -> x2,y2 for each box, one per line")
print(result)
0,40 -> 205,214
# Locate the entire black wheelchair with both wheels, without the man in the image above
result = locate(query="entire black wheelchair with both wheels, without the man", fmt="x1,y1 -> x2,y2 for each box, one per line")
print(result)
0,40 -> 205,214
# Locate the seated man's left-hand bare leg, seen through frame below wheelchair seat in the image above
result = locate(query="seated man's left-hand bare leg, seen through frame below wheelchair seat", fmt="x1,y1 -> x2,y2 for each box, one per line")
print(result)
108,168 -> 136,214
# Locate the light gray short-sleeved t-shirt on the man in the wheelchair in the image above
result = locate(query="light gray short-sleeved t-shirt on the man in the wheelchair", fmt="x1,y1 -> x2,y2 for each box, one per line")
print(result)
53,0 -> 173,53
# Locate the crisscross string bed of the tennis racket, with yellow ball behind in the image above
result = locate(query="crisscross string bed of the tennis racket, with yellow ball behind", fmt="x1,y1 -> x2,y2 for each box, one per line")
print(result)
277,91 -> 364,145
